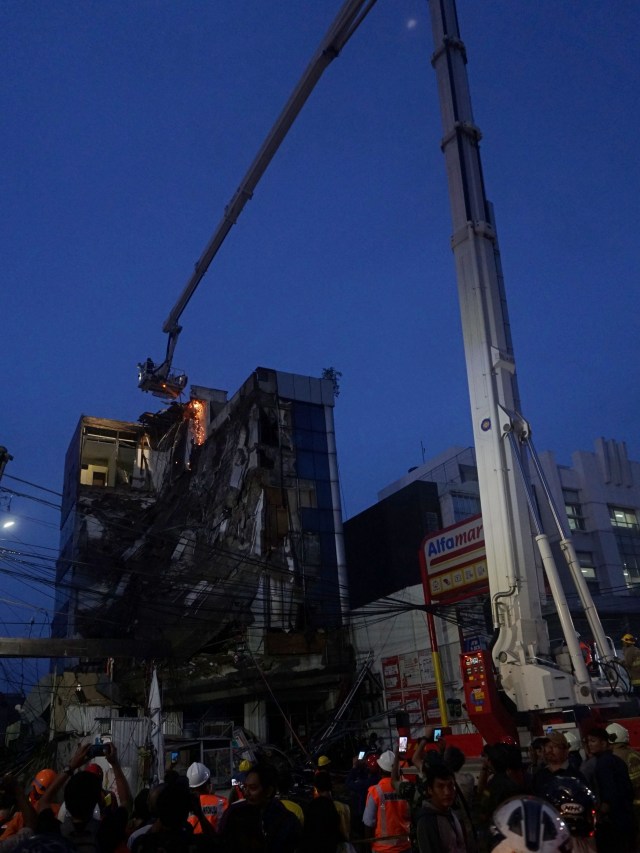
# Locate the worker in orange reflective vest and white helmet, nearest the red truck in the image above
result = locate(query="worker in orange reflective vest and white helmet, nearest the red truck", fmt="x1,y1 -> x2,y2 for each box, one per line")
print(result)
362,749 -> 411,853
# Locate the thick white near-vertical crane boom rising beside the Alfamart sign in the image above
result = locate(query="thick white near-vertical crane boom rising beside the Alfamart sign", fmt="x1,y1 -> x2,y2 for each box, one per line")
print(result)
429,0 -> 611,710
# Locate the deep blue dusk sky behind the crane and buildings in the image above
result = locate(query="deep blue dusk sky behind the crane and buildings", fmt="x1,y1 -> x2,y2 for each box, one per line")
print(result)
0,0 -> 640,672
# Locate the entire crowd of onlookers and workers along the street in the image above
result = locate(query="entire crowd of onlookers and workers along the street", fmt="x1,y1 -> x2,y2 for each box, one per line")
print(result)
0,723 -> 640,853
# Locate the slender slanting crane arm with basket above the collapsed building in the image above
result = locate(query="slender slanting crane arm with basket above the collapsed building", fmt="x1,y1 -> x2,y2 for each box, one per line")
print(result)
138,0 -> 376,397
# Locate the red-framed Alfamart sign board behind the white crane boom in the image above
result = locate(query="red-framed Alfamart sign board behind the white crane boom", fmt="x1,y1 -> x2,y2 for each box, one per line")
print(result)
420,515 -> 489,604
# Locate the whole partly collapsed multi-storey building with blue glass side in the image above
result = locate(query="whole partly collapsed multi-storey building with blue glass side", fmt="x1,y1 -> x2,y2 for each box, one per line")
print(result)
52,368 -> 353,740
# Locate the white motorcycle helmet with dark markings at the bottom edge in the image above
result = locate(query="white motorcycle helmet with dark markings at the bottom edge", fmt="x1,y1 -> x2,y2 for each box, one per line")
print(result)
491,797 -> 572,853
